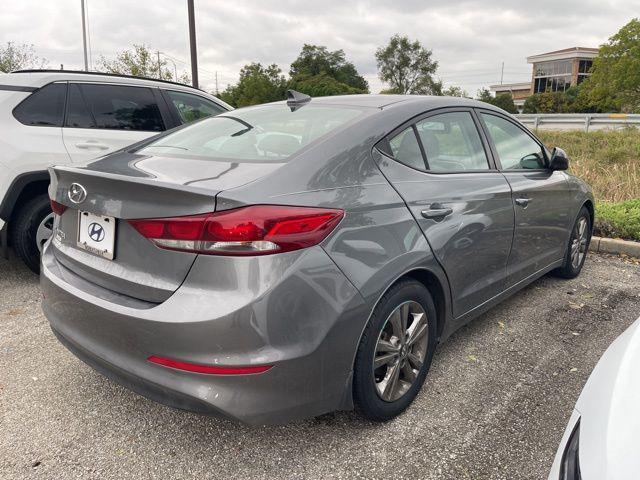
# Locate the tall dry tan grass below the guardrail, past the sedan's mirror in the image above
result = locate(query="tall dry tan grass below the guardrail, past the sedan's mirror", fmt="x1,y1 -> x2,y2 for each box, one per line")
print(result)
537,127 -> 640,202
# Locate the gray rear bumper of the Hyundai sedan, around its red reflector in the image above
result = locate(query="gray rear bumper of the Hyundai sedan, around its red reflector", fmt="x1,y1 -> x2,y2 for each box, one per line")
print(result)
41,243 -> 366,424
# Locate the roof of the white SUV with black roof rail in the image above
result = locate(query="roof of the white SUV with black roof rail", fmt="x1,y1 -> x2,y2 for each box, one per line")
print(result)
0,70 -> 211,96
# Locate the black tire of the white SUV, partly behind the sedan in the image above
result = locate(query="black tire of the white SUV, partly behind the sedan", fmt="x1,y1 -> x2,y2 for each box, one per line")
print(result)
9,195 -> 51,274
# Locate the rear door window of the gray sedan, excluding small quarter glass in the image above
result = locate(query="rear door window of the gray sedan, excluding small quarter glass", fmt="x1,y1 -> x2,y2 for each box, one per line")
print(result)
416,112 -> 489,172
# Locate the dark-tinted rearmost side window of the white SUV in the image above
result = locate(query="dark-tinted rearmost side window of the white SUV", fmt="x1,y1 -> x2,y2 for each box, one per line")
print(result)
13,83 -> 67,127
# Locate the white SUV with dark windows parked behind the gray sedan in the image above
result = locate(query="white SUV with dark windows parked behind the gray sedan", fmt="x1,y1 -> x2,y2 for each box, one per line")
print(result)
0,70 -> 231,273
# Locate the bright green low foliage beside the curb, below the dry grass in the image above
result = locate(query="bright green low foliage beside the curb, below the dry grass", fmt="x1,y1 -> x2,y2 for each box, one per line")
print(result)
594,198 -> 640,241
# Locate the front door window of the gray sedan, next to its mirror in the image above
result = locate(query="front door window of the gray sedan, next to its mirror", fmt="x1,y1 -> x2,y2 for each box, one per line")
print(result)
480,113 -> 545,170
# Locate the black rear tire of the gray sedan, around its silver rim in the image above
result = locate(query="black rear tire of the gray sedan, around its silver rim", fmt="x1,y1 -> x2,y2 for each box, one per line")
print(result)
353,279 -> 437,422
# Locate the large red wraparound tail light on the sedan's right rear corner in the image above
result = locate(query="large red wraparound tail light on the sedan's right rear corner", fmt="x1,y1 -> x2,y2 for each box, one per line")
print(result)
129,205 -> 344,255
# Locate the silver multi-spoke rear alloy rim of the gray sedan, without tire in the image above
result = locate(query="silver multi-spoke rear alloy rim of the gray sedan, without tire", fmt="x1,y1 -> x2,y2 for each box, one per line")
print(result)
373,301 -> 429,402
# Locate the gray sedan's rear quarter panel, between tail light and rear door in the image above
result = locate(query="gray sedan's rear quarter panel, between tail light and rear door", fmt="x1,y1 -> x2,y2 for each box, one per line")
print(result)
216,115 -> 450,348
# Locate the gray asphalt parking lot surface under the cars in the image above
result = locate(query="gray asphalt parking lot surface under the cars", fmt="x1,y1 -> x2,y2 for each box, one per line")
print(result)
0,255 -> 640,480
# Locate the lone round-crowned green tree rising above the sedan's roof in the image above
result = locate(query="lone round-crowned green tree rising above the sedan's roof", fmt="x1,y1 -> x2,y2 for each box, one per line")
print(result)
376,35 -> 442,95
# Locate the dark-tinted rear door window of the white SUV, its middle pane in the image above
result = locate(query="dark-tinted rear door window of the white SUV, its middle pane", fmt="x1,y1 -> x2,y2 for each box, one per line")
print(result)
66,84 -> 164,132
